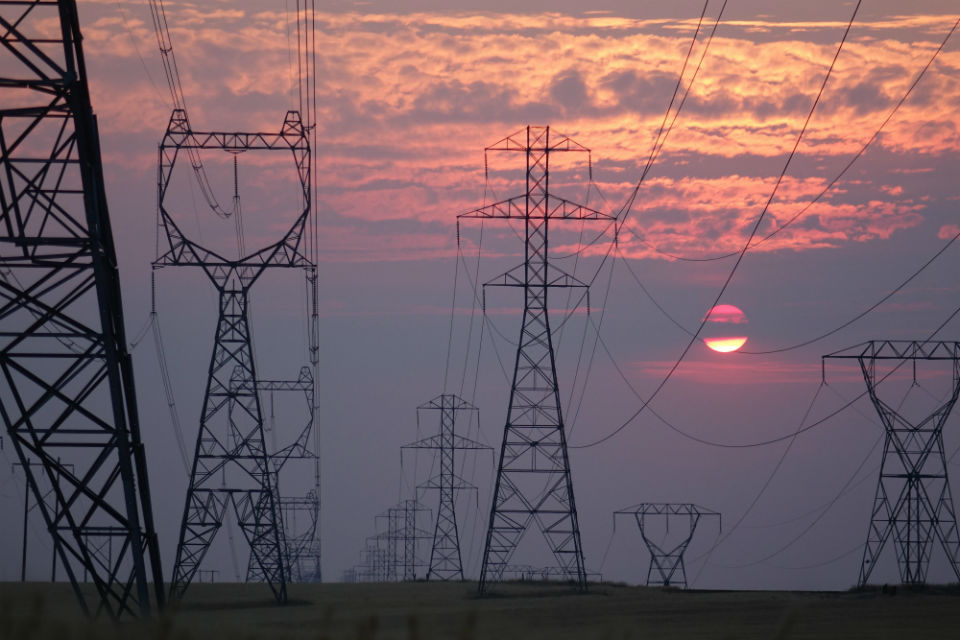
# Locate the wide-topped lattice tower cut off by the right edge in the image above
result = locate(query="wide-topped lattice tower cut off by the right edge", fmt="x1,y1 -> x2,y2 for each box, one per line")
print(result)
824,340 -> 960,587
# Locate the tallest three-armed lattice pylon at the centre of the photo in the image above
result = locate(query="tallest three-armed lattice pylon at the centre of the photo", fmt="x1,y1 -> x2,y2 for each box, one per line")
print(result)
459,126 -> 615,593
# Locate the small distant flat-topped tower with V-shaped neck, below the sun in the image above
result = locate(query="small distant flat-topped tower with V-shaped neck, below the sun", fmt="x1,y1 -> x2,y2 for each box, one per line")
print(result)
613,502 -> 720,589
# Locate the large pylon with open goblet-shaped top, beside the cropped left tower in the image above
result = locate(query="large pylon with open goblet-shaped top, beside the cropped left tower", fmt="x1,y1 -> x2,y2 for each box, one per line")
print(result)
154,109 -> 315,602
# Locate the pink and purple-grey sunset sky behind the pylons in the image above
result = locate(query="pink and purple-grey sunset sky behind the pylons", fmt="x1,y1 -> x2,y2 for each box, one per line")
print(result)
0,0 -> 960,588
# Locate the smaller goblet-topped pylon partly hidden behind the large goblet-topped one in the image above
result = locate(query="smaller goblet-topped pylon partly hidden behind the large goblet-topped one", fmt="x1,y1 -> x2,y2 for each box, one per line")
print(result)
244,367 -> 320,582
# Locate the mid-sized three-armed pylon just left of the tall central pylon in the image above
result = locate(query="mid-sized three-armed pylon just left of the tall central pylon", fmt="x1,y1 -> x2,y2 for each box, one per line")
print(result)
401,394 -> 491,580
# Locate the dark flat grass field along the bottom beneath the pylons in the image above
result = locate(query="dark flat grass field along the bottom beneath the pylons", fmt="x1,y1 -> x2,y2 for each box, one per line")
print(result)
0,583 -> 960,640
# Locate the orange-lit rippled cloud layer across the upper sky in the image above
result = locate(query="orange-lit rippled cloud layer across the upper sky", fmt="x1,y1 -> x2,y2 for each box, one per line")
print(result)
75,3 -> 960,258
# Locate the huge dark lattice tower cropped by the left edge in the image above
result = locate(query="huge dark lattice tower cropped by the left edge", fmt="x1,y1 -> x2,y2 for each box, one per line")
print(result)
0,0 -> 164,617
